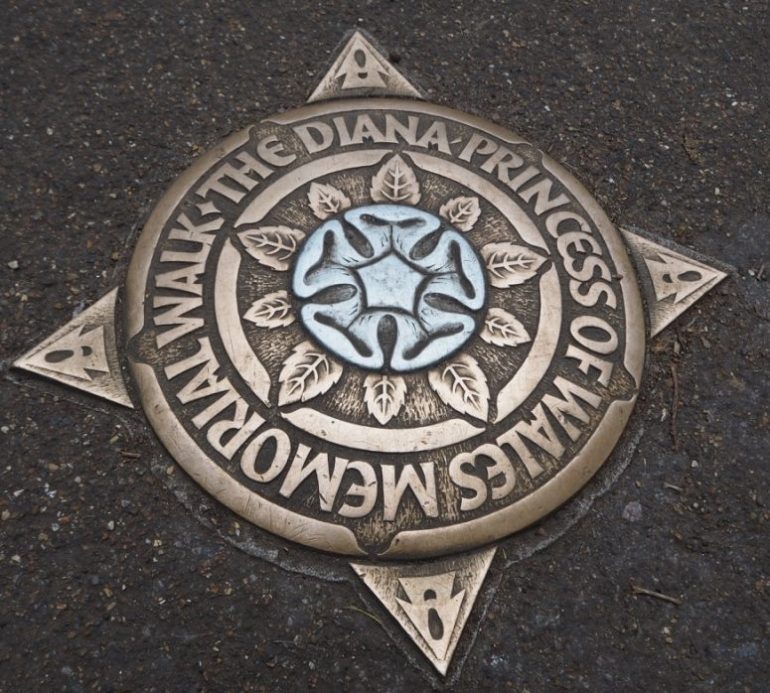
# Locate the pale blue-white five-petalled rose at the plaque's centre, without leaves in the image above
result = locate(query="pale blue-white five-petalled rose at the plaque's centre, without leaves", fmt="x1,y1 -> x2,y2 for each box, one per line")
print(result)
292,204 -> 486,372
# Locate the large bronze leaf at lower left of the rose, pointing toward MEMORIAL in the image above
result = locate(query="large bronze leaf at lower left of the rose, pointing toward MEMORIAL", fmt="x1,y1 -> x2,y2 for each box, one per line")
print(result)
278,341 -> 342,406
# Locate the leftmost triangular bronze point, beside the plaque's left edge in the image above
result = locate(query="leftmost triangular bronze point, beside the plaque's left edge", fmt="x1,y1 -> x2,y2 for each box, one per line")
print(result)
13,289 -> 133,407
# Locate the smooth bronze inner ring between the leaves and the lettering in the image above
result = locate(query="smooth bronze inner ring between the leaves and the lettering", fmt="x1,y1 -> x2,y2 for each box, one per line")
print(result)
215,149 -> 562,453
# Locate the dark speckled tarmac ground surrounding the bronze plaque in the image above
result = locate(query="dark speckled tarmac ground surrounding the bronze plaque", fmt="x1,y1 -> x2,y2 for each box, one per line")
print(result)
0,0 -> 770,691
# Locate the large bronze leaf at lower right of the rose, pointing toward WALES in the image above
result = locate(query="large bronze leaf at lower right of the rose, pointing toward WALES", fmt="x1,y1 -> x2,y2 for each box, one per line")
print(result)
428,354 -> 489,421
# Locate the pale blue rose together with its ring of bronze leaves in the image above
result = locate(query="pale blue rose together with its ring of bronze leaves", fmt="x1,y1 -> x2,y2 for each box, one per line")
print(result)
238,154 -> 546,426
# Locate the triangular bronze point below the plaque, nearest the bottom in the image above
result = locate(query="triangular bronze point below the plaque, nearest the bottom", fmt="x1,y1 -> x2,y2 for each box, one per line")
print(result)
350,548 -> 496,676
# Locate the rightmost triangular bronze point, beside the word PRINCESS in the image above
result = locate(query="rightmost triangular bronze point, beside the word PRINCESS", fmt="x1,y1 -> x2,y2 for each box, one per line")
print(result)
622,229 -> 727,337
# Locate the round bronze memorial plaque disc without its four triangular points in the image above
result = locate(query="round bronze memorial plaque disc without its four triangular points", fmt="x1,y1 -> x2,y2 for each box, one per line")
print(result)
125,99 -> 644,558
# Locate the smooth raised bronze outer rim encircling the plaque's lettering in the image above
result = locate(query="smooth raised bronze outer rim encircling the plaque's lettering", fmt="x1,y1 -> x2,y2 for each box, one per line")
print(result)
124,98 -> 645,559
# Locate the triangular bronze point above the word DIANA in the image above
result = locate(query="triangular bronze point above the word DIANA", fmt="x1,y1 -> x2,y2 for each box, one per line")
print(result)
308,31 -> 423,103
